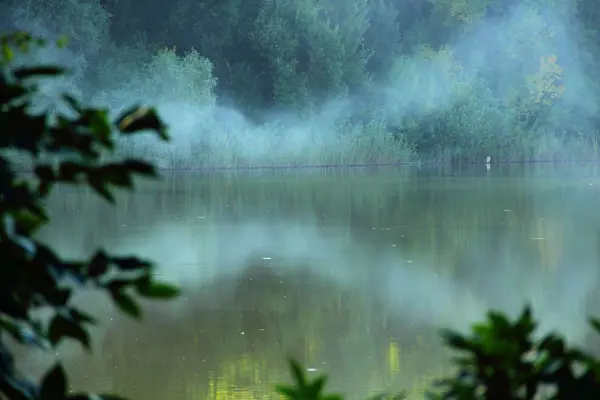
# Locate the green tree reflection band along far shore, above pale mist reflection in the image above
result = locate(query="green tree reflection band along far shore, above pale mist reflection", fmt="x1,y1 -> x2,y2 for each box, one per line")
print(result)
42,170 -> 576,278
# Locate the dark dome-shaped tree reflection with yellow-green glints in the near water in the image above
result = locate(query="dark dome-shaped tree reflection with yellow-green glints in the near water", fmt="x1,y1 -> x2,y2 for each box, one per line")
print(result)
63,265 -> 434,399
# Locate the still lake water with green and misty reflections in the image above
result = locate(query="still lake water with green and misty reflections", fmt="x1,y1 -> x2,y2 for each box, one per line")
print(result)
25,165 -> 600,400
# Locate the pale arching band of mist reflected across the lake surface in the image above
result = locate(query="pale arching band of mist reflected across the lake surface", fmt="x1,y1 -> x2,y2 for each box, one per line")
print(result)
38,212 -> 598,356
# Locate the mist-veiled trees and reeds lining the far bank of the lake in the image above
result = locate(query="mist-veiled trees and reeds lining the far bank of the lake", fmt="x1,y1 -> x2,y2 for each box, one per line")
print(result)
4,0 -> 600,166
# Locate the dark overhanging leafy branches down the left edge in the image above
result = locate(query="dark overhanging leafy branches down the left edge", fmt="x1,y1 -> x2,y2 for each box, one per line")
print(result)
0,32 -> 178,400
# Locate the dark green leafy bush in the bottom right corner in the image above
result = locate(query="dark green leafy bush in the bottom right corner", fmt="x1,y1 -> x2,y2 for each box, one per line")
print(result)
431,307 -> 600,400
